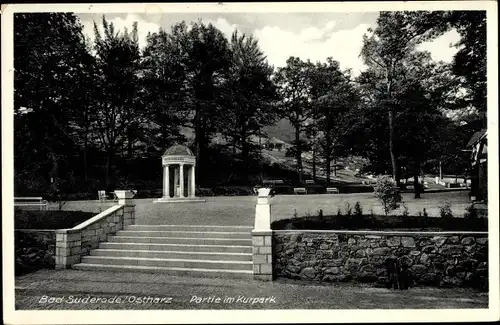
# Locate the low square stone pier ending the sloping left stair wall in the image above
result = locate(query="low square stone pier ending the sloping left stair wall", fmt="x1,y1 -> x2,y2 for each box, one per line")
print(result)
55,229 -> 82,269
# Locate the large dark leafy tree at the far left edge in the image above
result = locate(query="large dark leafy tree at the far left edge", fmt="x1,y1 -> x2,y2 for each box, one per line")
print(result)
14,13 -> 89,191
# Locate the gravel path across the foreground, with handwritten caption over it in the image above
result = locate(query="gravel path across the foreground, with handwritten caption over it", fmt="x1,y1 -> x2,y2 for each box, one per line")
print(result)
15,270 -> 488,310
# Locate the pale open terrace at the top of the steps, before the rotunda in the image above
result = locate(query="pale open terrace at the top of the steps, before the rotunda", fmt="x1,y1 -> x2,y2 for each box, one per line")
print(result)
58,191 -> 470,226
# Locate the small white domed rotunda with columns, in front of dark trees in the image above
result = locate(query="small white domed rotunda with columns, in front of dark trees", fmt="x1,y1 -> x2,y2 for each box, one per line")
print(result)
154,145 -> 205,203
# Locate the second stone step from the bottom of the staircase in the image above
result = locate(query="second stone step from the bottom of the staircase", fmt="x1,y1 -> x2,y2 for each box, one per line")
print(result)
81,256 -> 252,271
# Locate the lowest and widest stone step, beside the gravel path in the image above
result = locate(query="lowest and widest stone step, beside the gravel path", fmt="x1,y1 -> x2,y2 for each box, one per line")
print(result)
72,263 -> 253,279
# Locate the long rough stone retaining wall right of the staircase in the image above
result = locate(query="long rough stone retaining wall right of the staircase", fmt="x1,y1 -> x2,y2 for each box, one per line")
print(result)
273,231 -> 488,289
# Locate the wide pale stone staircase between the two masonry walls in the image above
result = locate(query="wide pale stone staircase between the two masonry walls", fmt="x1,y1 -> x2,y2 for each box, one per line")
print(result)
72,225 -> 253,279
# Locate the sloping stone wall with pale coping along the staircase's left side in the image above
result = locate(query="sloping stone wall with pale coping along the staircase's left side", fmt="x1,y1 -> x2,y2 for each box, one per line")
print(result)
56,205 -> 135,269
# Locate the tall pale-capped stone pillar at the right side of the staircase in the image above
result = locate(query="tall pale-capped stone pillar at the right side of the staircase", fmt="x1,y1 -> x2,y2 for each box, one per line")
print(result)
252,188 -> 273,281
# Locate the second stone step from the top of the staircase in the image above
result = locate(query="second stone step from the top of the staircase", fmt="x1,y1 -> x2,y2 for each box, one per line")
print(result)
108,235 -> 252,246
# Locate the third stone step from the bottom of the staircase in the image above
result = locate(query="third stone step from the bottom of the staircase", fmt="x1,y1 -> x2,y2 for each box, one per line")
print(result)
90,249 -> 252,261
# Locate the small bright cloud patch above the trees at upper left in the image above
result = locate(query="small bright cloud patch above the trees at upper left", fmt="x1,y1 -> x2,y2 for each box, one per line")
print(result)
82,14 -> 160,48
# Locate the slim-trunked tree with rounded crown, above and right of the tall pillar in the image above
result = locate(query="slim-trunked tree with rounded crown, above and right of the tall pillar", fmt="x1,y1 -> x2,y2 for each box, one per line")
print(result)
274,57 -> 314,182
